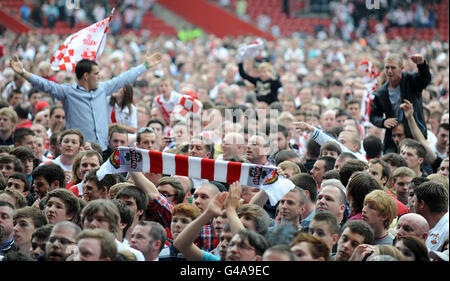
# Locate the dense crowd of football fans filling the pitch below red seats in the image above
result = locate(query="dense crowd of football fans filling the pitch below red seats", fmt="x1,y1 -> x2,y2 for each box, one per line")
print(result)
0,17 -> 449,261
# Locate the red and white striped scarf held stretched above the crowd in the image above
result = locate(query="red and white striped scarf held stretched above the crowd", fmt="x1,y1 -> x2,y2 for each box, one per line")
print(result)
97,146 -> 295,203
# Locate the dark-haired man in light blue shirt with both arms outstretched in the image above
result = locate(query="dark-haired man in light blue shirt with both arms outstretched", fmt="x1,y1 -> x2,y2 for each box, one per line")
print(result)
9,53 -> 162,150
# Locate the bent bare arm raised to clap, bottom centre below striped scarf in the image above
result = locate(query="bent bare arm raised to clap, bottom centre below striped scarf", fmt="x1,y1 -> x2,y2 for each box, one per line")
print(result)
173,192 -> 227,261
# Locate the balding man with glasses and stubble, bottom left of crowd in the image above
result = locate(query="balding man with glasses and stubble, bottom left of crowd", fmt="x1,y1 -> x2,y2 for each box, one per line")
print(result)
44,221 -> 81,261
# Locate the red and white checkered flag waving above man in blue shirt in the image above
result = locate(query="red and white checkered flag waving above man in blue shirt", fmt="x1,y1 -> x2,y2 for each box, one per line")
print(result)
50,9 -> 114,71
